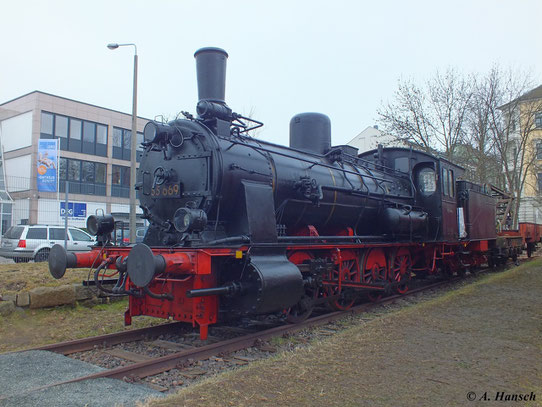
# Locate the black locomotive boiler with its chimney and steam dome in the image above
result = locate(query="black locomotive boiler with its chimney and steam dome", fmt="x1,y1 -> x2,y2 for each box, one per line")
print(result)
136,48 -> 427,246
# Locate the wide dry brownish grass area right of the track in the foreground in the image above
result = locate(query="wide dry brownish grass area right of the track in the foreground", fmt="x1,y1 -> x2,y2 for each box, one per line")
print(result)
147,260 -> 542,406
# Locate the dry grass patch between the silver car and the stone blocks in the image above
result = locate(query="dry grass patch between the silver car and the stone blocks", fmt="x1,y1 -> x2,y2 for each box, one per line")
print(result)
0,262 -> 88,294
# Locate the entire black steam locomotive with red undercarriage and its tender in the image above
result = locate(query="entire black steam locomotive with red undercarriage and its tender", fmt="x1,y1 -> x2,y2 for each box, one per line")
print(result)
49,48 -> 520,338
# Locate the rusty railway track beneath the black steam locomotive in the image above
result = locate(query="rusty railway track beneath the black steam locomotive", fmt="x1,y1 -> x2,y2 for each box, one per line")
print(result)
21,259 -> 530,391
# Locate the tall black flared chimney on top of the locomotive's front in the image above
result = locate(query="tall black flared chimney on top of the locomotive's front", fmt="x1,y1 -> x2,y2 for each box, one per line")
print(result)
194,47 -> 228,103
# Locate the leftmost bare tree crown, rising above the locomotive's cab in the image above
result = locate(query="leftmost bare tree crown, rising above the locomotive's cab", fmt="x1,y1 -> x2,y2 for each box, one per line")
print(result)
378,69 -> 472,159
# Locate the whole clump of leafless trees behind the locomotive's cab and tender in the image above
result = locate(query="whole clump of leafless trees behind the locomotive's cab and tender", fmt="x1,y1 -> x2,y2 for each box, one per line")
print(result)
378,67 -> 542,227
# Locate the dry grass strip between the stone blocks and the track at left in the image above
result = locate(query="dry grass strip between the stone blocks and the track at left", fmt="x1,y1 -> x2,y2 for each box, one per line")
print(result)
0,300 -> 165,352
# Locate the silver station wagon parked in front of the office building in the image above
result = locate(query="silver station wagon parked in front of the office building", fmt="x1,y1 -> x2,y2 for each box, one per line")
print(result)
0,225 -> 95,263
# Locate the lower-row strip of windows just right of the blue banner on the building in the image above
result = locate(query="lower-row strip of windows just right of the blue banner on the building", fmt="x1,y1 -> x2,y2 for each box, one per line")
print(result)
58,157 -> 106,196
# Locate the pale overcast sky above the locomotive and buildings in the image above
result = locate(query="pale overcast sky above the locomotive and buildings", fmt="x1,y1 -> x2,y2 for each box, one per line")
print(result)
0,0 -> 542,144
